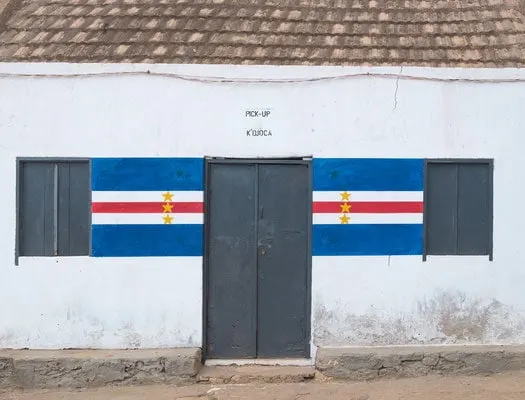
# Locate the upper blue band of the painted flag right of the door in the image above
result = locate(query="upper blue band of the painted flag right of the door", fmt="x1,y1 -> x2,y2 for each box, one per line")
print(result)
313,158 -> 424,191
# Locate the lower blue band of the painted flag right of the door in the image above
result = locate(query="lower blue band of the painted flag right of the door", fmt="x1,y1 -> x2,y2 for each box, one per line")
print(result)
312,224 -> 423,256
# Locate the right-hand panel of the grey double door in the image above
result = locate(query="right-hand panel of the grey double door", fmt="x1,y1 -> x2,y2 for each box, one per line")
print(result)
257,164 -> 310,358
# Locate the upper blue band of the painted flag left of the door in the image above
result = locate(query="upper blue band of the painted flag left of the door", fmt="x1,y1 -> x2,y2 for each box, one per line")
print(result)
91,157 -> 204,191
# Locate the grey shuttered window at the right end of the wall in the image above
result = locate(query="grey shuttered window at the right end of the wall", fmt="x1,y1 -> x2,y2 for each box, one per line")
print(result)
423,160 -> 493,260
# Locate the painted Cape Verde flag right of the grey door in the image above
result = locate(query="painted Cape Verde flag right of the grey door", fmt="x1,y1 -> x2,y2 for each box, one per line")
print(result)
312,158 -> 424,256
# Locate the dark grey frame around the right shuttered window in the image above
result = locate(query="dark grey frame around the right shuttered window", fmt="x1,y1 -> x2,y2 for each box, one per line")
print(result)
422,158 -> 494,262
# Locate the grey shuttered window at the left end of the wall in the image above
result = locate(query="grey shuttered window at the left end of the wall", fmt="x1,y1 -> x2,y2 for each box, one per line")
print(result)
17,160 -> 90,256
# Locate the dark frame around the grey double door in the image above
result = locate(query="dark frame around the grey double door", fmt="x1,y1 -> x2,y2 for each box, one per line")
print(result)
201,156 -> 313,363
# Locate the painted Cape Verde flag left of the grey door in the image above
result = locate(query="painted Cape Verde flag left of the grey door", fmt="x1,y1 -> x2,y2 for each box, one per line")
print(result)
91,158 -> 204,257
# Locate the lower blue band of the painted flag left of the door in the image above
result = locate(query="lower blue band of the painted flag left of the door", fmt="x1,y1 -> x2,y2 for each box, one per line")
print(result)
91,224 -> 203,257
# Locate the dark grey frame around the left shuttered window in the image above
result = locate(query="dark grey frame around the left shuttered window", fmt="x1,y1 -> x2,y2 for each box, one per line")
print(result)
15,157 -> 92,266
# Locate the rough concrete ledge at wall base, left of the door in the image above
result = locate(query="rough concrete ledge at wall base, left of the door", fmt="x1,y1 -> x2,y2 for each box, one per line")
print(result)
0,348 -> 201,389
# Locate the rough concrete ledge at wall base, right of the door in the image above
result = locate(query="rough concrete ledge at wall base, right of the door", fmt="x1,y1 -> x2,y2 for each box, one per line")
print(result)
316,346 -> 525,380
